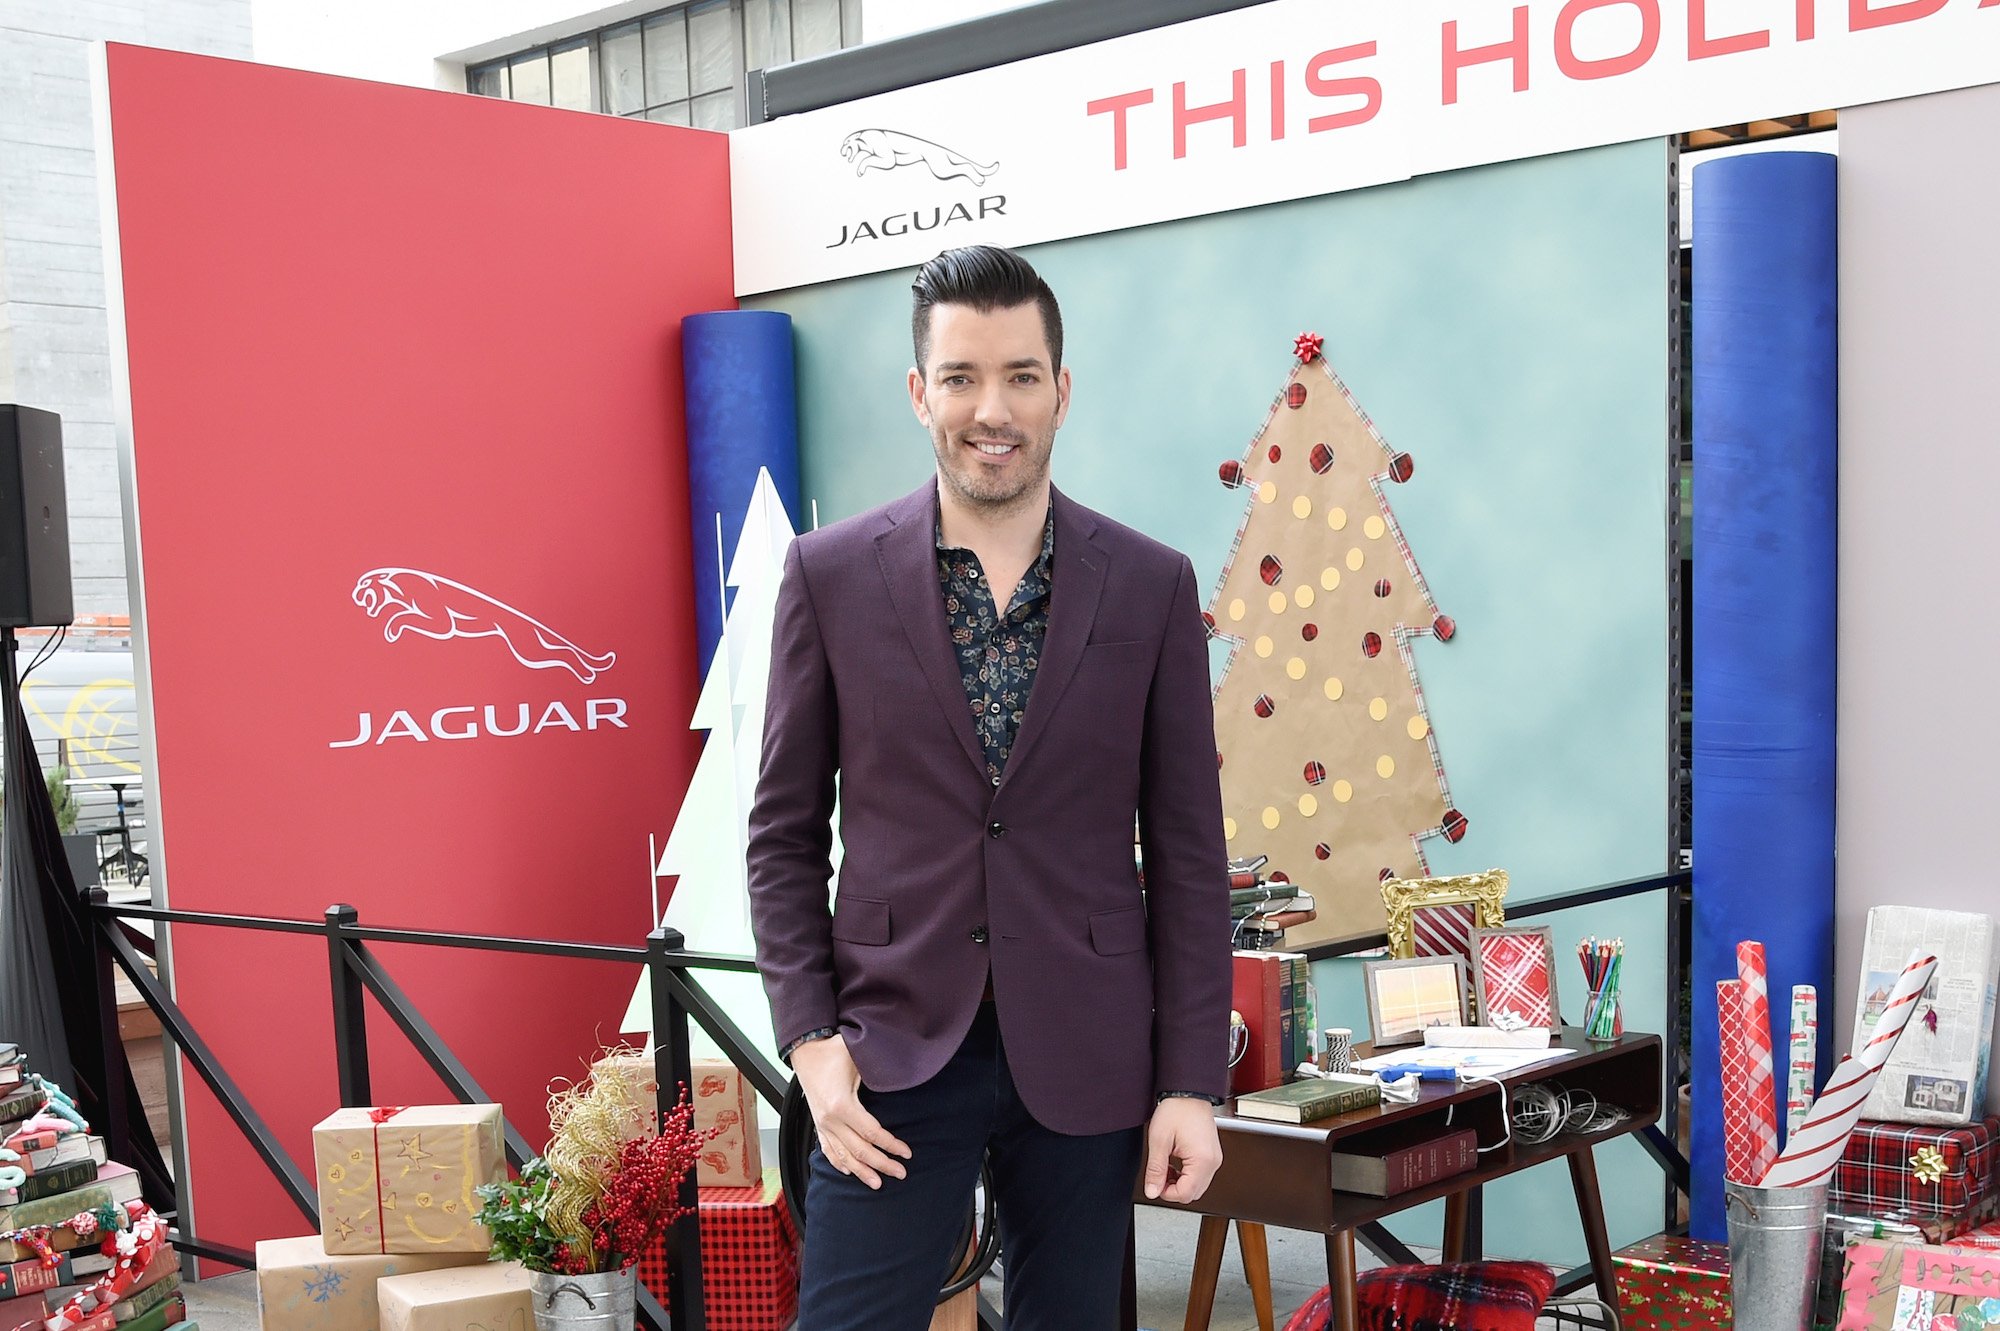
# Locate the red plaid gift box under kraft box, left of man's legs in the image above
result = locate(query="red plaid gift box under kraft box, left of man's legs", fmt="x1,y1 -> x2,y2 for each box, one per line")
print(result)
638,1169 -> 798,1331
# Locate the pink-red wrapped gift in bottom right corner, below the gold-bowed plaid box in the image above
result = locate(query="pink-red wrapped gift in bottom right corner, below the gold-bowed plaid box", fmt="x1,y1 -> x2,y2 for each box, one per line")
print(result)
1836,1239 -> 2000,1331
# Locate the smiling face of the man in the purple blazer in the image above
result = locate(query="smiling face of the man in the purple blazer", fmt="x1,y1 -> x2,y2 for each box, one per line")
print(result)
910,300 -> 1070,512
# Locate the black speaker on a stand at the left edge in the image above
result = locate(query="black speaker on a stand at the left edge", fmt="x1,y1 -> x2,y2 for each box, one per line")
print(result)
0,402 -> 76,628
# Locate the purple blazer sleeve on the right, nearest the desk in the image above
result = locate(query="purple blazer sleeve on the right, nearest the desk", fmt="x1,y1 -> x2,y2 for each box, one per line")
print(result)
1138,558 -> 1230,1097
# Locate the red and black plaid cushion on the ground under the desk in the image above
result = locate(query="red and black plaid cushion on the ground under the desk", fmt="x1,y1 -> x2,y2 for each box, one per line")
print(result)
1284,1261 -> 1556,1331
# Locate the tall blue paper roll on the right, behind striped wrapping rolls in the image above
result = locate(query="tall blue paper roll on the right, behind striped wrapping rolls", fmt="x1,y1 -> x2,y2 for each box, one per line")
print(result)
1690,152 -> 1838,1239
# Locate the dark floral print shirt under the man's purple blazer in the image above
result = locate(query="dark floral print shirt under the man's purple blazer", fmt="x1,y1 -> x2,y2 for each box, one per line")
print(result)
938,508 -> 1056,785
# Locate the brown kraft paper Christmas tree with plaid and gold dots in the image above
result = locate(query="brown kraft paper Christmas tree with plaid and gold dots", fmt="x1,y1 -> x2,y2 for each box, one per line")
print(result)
1204,334 -> 1466,947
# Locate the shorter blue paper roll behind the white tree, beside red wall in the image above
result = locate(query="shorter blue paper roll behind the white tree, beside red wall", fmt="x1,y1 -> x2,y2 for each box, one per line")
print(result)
680,310 -> 804,671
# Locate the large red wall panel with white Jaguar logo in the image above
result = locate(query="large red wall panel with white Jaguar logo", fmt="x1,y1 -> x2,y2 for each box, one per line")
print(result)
100,46 -> 734,1247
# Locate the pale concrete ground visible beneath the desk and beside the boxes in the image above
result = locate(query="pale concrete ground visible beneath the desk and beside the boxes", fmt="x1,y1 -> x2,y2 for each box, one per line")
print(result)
186,1207 -> 1436,1331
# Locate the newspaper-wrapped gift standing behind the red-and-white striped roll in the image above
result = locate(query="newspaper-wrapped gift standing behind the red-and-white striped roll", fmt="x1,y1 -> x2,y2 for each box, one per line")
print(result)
1854,905 -> 2000,1123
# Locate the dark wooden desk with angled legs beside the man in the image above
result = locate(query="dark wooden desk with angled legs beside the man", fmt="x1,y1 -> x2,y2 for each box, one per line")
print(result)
1126,1029 -> 1662,1331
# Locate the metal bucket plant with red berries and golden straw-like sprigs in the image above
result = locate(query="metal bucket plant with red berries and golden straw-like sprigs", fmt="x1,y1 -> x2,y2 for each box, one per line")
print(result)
478,1049 -> 722,1331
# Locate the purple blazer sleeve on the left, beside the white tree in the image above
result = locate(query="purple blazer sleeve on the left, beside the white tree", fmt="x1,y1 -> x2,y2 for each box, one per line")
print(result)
748,542 -> 840,1049
